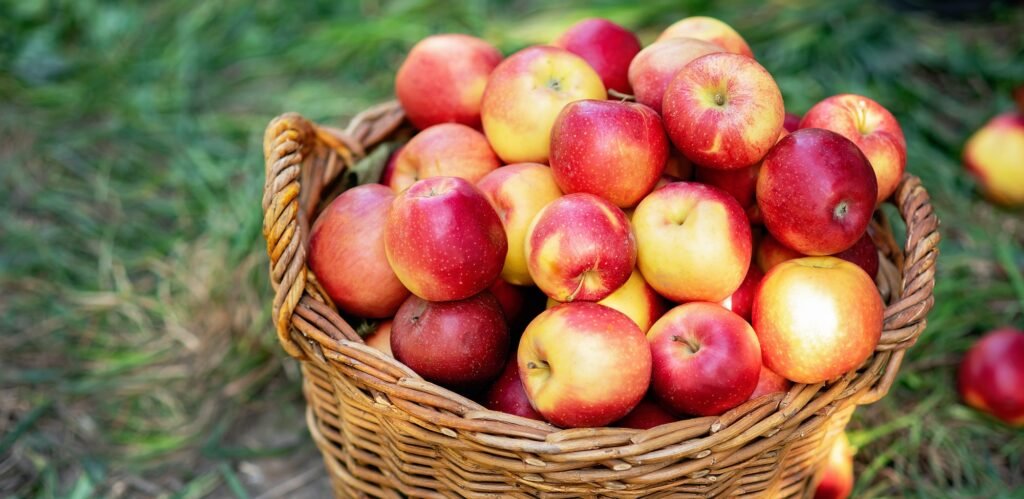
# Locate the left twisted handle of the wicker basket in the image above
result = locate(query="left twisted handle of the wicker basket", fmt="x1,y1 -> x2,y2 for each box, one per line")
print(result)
263,101 -> 404,360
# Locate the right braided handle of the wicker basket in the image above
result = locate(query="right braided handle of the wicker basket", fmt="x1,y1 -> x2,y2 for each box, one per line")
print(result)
857,173 -> 940,405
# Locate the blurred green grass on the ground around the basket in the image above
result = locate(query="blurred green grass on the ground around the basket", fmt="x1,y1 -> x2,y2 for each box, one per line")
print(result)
0,0 -> 1024,497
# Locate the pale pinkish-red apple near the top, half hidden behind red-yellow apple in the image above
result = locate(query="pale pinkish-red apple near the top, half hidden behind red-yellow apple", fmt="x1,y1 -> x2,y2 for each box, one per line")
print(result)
629,38 -> 725,114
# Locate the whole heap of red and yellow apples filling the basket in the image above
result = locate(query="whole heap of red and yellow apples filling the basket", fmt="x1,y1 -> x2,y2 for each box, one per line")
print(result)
308,17 -> 906,428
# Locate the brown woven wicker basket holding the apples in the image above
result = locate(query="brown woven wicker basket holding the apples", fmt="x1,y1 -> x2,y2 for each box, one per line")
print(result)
263,102 -> 939,497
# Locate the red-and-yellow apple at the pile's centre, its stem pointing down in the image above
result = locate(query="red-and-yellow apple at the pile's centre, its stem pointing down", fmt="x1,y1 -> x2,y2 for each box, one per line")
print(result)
526,193 -> 637,303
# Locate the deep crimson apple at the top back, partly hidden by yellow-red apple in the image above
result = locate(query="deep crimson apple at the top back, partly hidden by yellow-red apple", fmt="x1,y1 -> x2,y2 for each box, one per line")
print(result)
554,18 -> 640,93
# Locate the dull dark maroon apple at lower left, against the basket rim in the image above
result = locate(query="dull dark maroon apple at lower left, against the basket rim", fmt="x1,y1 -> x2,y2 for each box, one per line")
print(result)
391,291 -> 509,389
